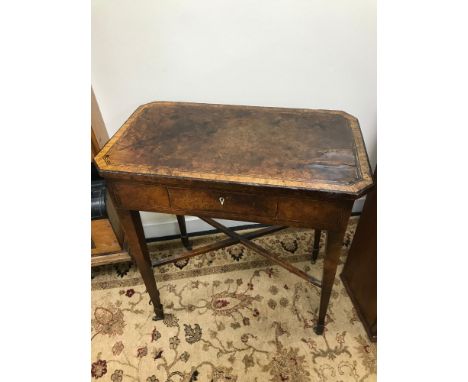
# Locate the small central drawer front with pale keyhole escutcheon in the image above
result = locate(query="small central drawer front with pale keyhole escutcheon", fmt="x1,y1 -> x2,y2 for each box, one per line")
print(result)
168,188 -> 277,217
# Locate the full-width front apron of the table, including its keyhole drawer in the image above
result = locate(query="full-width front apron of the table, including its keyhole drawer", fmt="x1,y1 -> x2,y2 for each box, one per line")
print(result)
109,182 -> 353,231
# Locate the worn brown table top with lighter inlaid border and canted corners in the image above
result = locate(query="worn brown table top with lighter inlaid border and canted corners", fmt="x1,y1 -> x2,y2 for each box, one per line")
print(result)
95,102 -> 372,197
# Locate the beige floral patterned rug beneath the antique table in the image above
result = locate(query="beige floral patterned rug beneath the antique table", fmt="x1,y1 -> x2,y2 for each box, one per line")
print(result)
91,218 -> 376,382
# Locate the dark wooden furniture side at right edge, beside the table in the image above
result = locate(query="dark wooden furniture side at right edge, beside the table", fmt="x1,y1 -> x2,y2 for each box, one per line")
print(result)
341,172 -> 377,342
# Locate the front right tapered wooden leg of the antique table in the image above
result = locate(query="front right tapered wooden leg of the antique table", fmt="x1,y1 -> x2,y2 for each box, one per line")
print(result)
314,229 -> 346,334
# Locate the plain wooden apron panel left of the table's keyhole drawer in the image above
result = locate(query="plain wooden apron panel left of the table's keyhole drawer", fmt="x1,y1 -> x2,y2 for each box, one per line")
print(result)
113,183 -> 170,211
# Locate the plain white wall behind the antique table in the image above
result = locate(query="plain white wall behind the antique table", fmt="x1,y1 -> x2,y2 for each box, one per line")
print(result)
91,0 -> 377,236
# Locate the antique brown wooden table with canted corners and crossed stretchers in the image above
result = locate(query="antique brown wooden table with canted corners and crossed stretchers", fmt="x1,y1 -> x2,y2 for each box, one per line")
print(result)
95,102 -> 373,334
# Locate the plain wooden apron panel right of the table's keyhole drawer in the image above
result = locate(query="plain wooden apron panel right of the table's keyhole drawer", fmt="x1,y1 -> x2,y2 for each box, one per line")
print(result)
277,198 -> 349,230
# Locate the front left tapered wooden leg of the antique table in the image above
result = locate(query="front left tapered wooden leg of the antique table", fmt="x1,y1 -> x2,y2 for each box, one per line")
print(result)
117,209 -> 164,321
